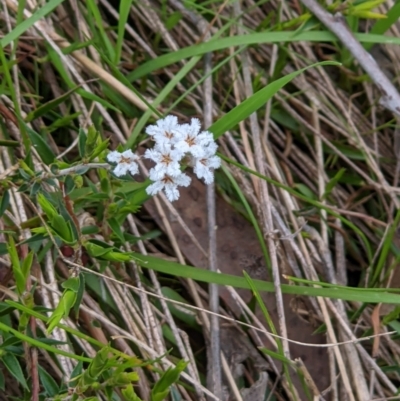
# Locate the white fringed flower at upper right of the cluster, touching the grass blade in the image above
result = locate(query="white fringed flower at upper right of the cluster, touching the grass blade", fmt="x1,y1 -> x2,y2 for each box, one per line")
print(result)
175,118 -> 214,157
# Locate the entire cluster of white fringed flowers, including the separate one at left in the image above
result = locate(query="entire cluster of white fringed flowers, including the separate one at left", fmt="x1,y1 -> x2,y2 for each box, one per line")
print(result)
107,116 -> 221,202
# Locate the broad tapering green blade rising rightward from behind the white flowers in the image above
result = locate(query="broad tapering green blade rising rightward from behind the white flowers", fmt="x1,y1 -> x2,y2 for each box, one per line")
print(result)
209,61 -> 340,139
